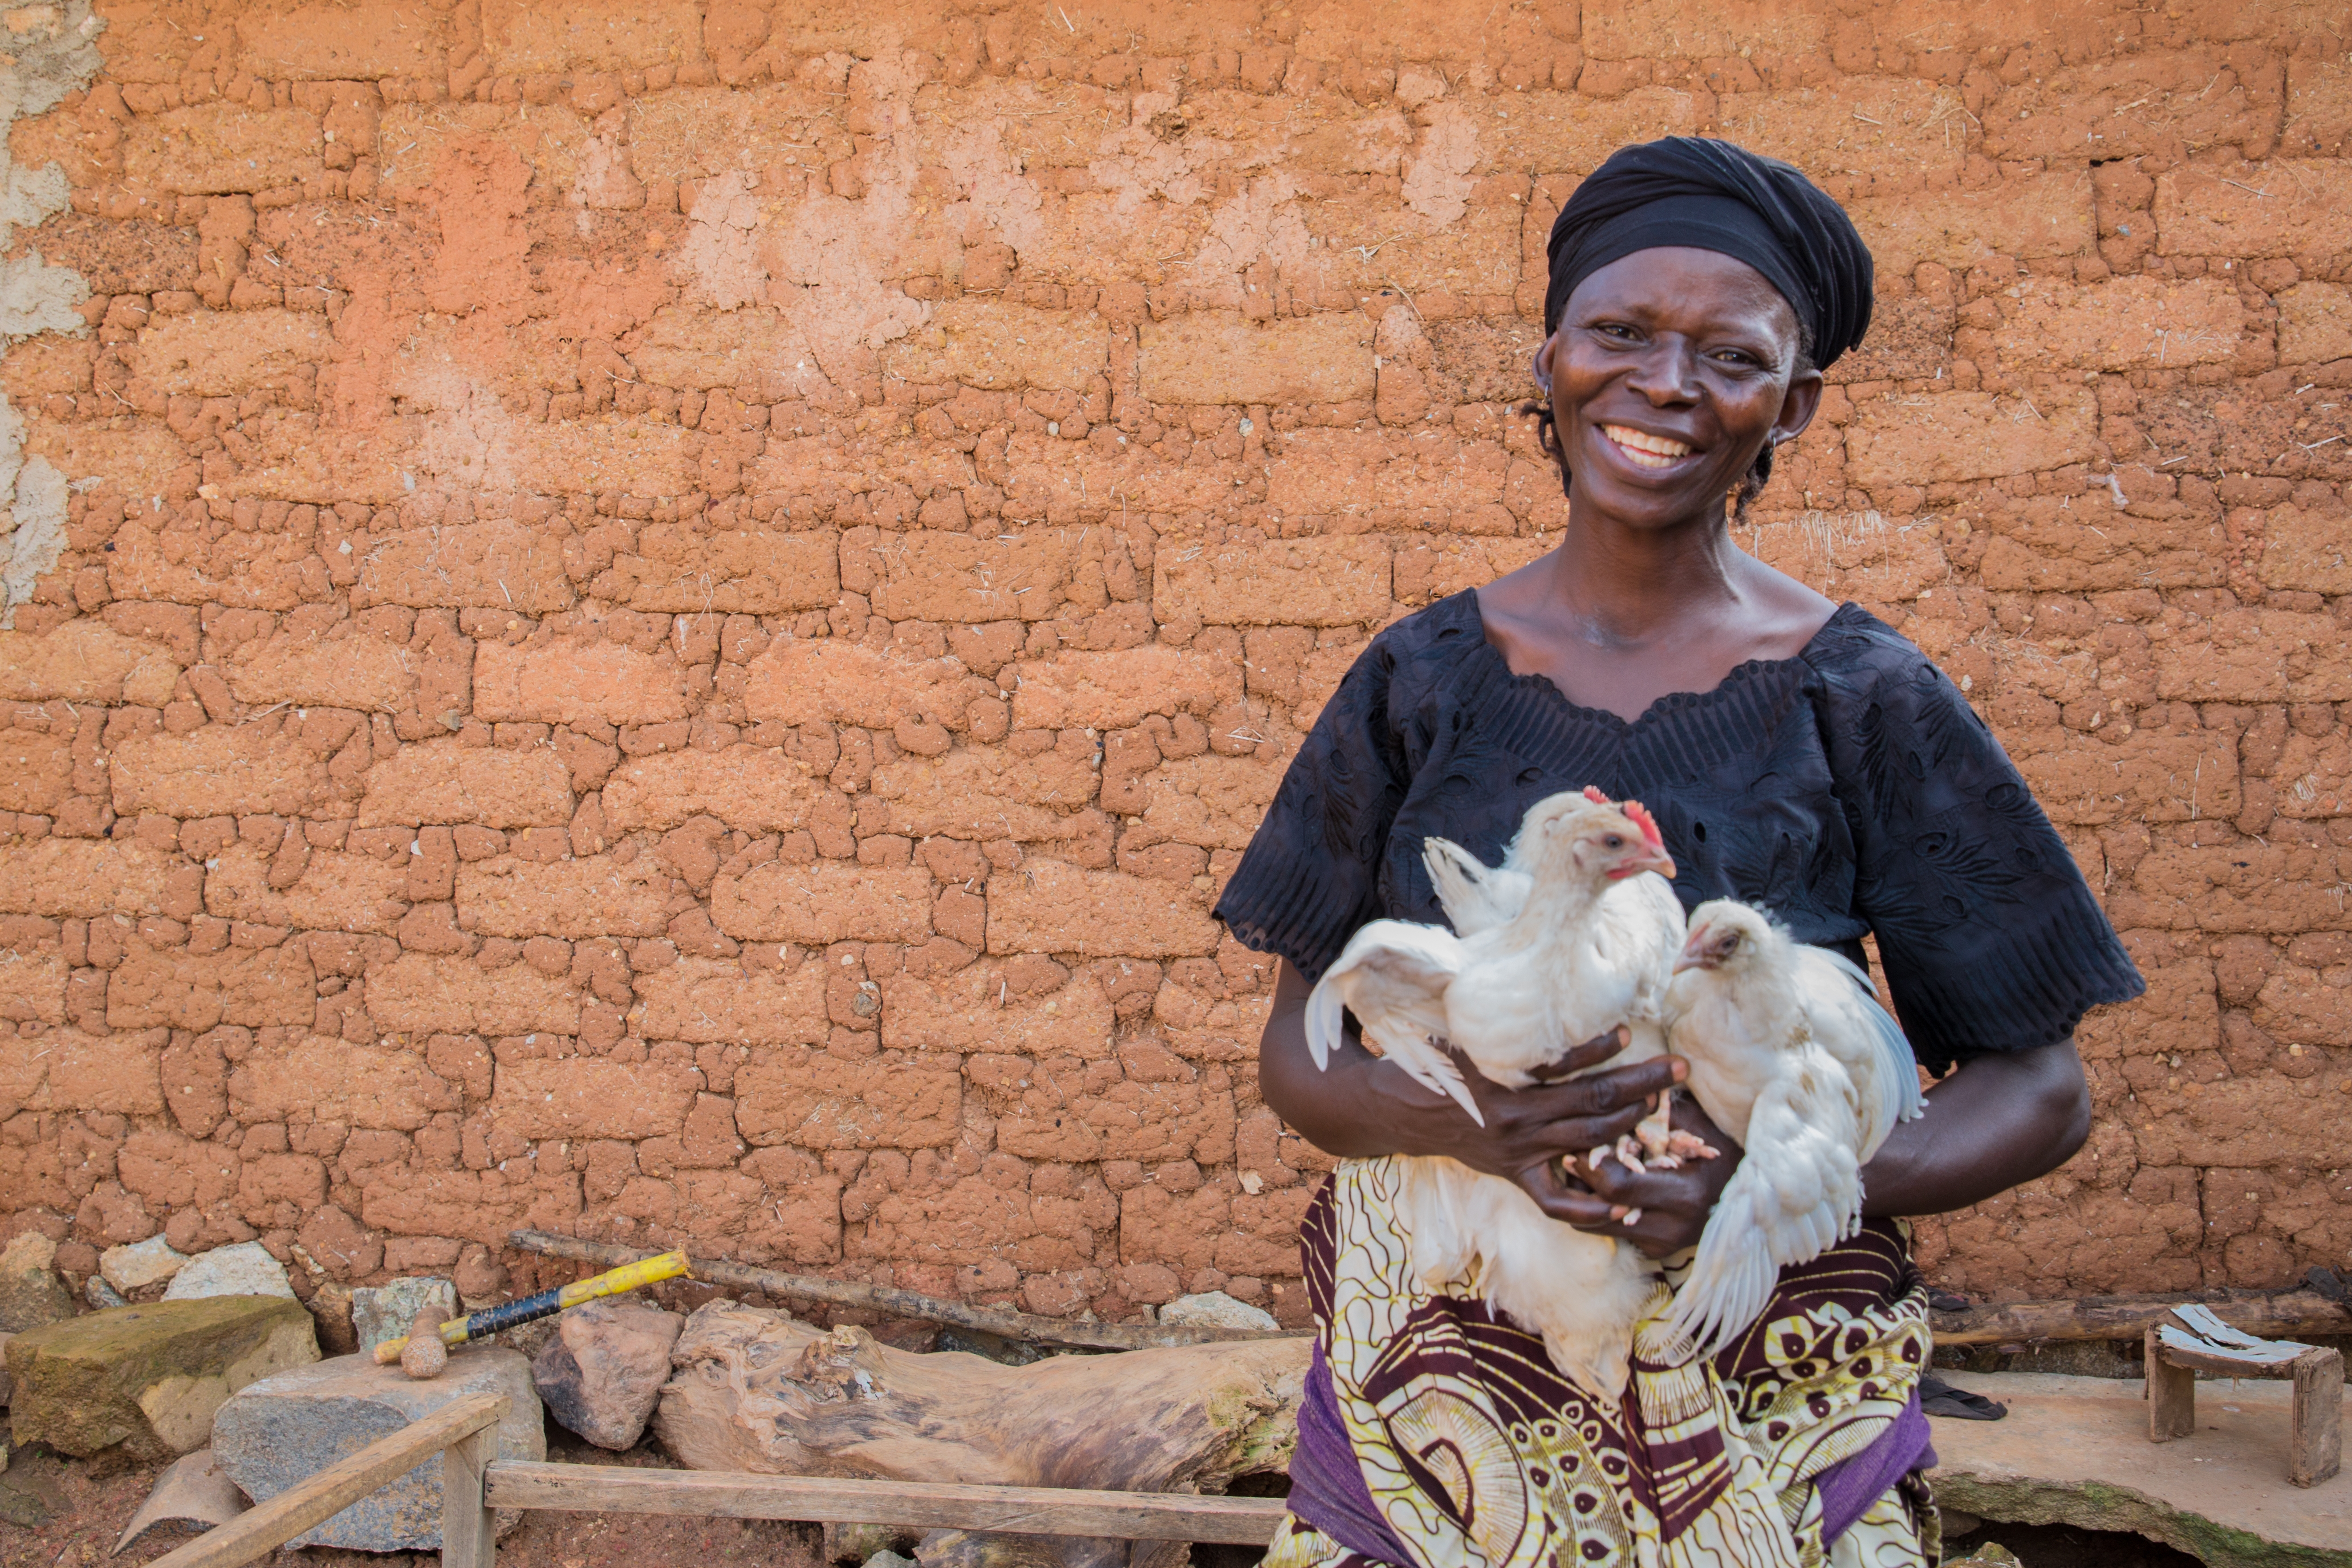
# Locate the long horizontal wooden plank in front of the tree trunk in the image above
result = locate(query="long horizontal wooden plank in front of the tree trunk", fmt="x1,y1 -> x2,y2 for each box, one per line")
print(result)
487,1460 -> 1284,1547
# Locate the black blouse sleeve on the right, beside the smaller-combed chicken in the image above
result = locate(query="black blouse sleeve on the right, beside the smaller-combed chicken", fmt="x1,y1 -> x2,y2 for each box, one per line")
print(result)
1830,628 -> 2145,1072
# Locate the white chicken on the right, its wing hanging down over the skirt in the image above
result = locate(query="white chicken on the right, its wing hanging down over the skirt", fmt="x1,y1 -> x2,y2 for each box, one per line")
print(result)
1668,898 -> 1926,1354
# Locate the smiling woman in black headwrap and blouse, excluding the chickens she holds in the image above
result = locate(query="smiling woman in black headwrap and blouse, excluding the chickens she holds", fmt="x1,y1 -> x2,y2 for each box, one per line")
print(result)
1219,139 -> 2141,1568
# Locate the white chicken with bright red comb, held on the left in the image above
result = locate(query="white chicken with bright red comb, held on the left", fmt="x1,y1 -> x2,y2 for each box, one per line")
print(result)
1305,795 -> 1682,1399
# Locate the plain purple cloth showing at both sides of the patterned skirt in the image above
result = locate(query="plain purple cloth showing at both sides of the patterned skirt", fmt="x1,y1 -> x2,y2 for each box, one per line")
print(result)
1289,1342 -> 1936,1568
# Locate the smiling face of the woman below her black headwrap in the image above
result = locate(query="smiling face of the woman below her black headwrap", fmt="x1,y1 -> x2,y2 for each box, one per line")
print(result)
1545,244 -> 1820,529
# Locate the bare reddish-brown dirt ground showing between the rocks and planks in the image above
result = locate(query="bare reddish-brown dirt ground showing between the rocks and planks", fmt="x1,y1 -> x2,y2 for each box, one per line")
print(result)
0,1422 -> 2197,1568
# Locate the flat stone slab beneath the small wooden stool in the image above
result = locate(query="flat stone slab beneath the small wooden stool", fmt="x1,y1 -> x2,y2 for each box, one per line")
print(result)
1929,1373 -> 2352,1568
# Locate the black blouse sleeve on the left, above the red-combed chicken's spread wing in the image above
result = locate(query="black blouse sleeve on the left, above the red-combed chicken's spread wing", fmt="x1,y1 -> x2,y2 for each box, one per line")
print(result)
1216,637 -> 1406,980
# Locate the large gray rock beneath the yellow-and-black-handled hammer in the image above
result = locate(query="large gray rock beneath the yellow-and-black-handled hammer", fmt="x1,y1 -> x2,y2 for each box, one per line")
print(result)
211,1345 -> 548,1552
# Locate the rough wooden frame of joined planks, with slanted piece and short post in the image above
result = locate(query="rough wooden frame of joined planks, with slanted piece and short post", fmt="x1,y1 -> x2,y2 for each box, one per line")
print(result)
148,1394 -> 1284,1568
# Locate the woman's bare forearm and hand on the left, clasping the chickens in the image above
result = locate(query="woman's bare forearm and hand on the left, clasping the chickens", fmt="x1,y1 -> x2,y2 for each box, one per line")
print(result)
1258,964 -> 1689,1189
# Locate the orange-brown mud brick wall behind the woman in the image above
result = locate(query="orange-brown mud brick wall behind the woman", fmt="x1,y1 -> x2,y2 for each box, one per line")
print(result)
0,0 -> 2352,1319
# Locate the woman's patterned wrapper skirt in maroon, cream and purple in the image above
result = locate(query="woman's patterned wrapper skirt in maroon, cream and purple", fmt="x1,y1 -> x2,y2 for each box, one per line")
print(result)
1265,1159 -> 1940,1568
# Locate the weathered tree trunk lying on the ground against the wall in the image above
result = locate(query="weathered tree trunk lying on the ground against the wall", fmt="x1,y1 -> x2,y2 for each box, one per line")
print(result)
654,1300 -> 1308,1568
